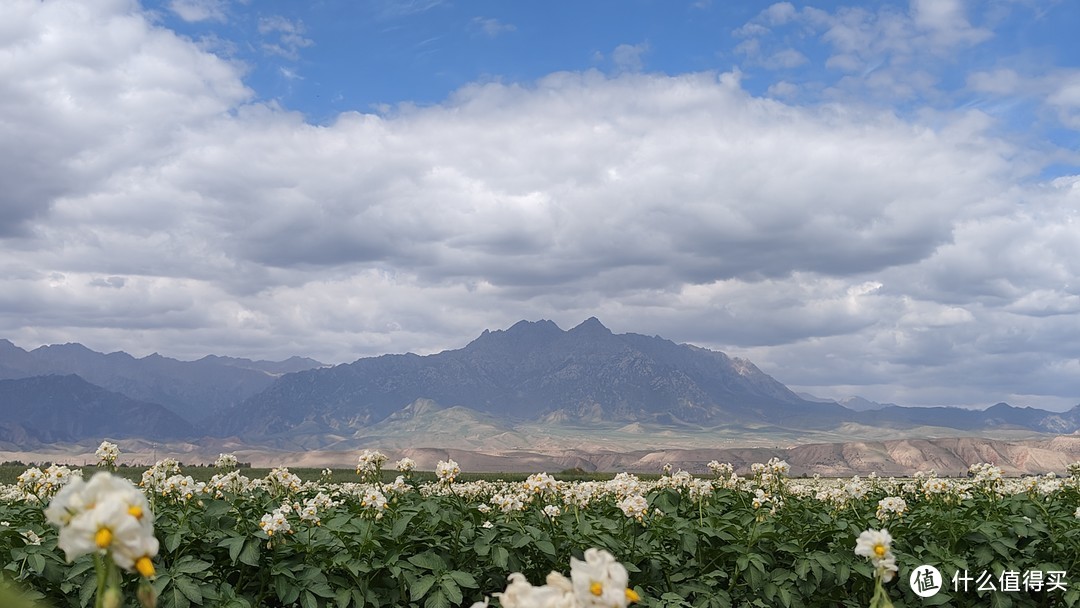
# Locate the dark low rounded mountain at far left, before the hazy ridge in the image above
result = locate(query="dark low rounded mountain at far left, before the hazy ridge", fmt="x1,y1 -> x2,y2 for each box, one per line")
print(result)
0,375 -> 195,445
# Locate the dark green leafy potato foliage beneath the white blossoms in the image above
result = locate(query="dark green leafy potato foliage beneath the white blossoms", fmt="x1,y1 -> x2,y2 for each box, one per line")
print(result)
0,471 -> 1080,608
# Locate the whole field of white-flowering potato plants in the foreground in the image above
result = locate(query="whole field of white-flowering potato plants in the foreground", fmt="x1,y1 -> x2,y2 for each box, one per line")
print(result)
0,451 -> 1080,608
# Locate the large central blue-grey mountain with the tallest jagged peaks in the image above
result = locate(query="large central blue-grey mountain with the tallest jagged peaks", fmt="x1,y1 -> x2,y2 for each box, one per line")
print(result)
214,319 -> 845,436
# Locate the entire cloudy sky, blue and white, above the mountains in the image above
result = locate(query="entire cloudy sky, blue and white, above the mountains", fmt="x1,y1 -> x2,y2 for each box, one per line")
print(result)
0,0 -> 1080,410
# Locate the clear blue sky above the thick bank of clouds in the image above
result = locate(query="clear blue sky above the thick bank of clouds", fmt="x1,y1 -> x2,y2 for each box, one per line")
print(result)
147,0 -> 1080,159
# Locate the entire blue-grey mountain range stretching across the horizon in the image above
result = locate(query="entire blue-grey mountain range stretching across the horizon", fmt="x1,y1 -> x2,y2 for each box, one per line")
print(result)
0,319 -> 1080,448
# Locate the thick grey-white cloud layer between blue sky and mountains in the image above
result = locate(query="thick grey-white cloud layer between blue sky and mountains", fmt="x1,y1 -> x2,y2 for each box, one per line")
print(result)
0,0 -> 1080,408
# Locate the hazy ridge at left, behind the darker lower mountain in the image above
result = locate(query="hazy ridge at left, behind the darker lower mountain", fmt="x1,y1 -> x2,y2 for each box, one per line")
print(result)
0,340 -> 322,423
